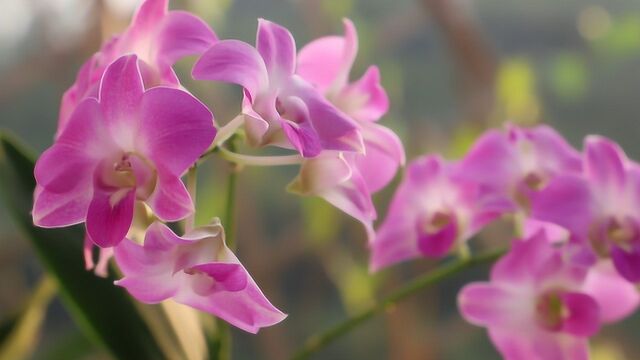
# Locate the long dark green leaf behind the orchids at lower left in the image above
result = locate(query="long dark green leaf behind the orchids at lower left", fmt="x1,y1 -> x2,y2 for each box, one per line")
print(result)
0,132 -> 166,359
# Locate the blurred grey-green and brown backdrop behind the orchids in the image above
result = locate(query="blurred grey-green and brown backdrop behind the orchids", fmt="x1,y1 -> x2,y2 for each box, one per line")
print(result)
0,0 -> 640,360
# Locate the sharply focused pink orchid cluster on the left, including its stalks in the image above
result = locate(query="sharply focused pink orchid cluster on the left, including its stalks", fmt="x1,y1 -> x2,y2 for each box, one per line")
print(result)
33,0 -> 404,333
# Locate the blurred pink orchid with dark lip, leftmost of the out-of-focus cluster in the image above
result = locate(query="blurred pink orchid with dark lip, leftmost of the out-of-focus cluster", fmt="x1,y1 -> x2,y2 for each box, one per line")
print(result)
370,156 -> 513,270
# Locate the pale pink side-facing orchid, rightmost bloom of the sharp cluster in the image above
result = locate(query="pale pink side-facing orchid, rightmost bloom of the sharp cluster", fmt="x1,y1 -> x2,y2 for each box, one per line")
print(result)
289,19 -> 405,235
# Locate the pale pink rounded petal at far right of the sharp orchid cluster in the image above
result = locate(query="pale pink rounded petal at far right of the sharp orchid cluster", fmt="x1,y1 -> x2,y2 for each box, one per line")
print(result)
355,123 -> 405,193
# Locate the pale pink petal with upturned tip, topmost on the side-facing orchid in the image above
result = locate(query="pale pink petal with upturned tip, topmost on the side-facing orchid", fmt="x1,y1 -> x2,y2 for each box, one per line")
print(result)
297,19 -> 358,93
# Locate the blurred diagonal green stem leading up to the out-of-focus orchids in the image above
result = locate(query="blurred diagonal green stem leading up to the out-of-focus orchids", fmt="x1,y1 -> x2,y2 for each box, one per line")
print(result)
291,249 -> 506,360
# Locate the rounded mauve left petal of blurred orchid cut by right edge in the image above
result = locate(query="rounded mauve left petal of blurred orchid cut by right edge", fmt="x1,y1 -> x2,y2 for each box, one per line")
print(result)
531,174 -> 593,238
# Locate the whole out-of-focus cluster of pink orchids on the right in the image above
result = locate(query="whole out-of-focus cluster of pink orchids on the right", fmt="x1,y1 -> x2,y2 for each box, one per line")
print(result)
371,125 -> 640,360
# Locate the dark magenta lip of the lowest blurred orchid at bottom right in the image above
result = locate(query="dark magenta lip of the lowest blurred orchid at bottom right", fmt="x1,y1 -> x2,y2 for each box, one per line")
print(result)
560,292 -> 600,337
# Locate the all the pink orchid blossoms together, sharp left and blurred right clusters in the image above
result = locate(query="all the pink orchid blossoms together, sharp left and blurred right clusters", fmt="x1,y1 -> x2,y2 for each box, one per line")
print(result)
33,0 -> 640,359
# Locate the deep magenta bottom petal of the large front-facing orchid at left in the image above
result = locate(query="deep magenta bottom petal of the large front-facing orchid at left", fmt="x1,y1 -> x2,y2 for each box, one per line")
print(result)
87,185 -> 135,248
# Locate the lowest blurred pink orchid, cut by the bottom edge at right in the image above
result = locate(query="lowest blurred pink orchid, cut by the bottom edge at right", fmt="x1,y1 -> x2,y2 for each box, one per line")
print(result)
458,231 -> 600,360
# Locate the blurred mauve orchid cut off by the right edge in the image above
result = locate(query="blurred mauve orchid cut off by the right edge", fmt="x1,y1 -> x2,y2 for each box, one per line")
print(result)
532,136 -> 640,282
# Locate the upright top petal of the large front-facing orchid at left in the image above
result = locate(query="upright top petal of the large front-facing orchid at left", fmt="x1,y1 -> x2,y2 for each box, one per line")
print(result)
100,55 -> 144,124
